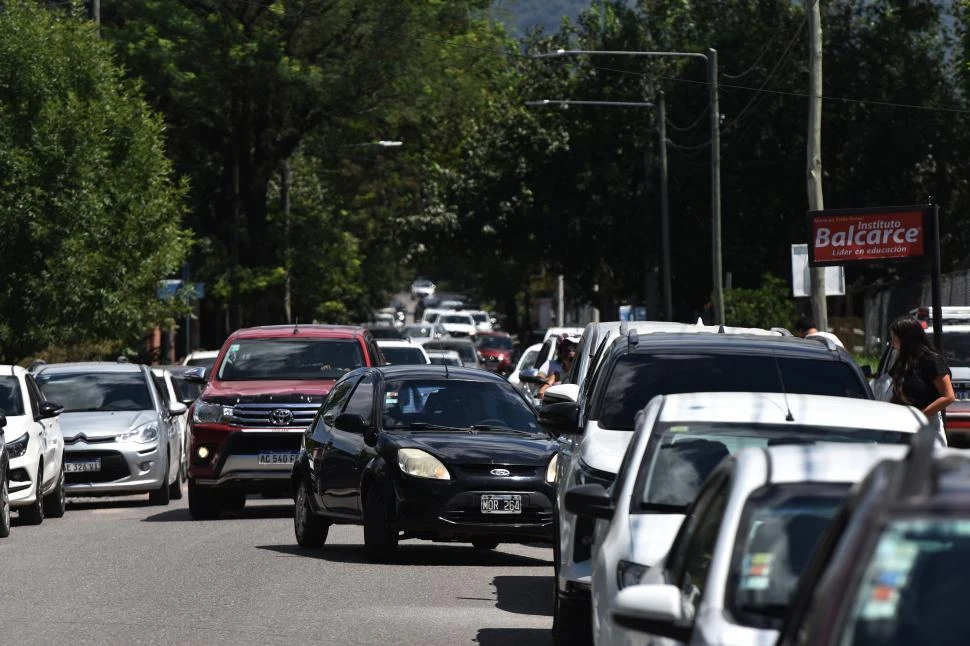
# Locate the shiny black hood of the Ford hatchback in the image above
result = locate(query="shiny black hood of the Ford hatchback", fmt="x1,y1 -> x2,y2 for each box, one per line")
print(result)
395,432 -> 558,466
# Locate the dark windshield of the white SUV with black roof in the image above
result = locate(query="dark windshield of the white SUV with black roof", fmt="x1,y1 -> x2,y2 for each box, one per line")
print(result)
590,353 -> 870,431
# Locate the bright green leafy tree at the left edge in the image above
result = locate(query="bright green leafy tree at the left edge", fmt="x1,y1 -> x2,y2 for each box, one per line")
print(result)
0,0 -> 189,362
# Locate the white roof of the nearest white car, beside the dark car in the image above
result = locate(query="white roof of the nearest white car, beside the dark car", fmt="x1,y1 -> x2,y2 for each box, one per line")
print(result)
737,443 -> 909,484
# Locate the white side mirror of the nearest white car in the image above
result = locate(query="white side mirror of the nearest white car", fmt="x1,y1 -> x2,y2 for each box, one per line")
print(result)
613,584 -> 692,643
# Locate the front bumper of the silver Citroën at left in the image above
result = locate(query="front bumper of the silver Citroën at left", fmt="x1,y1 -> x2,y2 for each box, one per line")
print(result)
64,441 -> 168,496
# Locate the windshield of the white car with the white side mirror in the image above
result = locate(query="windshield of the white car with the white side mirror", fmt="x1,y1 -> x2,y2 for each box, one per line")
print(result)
726,482 -> 850,630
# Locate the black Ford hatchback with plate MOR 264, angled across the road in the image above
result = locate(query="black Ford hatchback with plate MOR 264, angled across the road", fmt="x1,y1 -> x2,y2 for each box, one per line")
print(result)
292,365 -> 557,561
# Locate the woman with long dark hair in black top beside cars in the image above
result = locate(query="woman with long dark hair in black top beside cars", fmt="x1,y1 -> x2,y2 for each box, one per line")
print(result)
889,315 -> 956,446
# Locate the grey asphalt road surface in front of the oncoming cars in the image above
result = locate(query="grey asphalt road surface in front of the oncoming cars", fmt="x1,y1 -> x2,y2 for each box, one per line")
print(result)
0,496 -> 553,646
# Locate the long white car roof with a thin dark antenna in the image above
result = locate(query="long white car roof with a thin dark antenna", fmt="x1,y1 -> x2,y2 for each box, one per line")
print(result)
657,392 -> 926,433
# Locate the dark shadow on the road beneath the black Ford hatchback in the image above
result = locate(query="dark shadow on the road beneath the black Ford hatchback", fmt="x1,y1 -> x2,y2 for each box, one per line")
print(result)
256,543 -> 552,568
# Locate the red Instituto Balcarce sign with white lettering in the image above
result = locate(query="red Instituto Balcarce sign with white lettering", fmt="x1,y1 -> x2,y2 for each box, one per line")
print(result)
809,208 -> 927,265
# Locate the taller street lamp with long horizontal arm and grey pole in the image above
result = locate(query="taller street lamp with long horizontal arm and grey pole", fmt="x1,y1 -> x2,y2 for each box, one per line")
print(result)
535,49 -> 725,323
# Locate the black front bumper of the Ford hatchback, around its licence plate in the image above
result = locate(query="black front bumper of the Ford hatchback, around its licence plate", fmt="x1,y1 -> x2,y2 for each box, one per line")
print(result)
388,476 -> 555,542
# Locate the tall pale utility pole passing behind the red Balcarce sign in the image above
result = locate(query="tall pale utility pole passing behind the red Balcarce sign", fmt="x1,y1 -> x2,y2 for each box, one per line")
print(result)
805,0 -> 829,332
